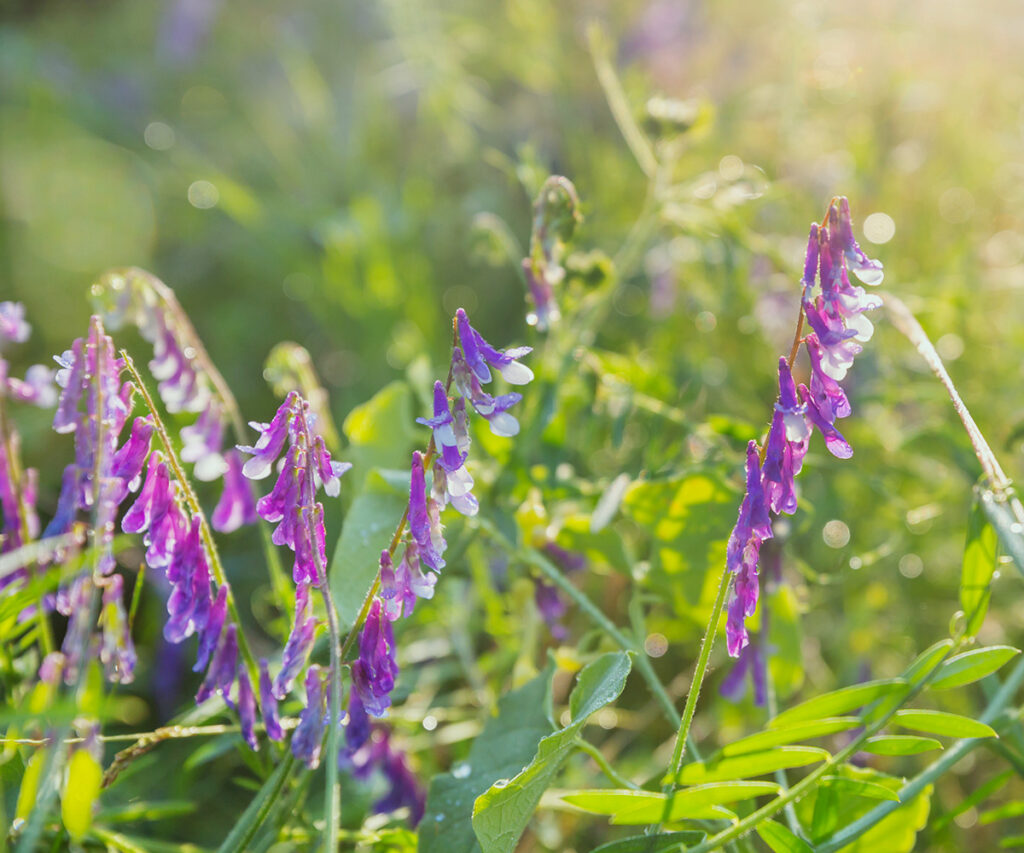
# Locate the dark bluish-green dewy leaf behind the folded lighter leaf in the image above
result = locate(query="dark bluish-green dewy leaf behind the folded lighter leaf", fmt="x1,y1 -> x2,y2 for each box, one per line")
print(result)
419,668 -> 553,853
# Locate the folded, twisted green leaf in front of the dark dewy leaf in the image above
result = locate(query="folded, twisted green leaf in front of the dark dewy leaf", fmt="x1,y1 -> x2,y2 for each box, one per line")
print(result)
473,651 -> 631,853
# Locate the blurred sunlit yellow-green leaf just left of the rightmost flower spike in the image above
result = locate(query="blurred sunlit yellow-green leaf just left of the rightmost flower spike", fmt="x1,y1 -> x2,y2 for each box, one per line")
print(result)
623,473 -> 737,626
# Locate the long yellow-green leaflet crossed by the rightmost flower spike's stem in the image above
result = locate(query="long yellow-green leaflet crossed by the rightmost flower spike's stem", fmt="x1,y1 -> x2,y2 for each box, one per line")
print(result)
561,781 -> 779,825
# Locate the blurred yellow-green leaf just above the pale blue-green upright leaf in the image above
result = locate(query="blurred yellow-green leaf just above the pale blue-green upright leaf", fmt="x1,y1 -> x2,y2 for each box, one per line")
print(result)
341,381 -> 416,485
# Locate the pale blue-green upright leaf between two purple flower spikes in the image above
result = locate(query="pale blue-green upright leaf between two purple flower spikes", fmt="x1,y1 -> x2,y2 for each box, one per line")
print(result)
330,470 -> 409,629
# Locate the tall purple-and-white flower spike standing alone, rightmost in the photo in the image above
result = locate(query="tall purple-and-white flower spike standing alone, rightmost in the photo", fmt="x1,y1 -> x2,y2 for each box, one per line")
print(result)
726,198 -> 883,657
